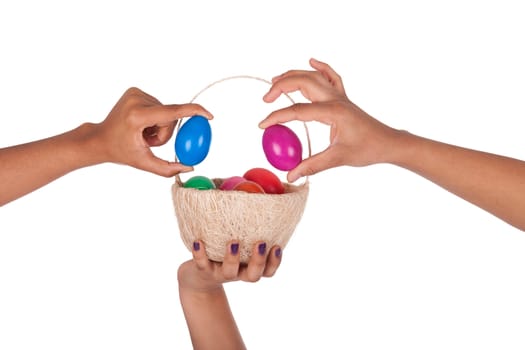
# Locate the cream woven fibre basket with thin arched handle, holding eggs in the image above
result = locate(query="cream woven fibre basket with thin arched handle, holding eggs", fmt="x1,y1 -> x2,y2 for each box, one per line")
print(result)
171,76 -> 311,263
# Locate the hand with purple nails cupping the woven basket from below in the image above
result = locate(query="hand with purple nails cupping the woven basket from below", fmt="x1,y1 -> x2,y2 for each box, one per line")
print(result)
178,241 -> 282,292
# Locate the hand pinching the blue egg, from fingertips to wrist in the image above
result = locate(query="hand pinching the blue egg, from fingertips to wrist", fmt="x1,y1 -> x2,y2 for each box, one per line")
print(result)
94,88 -> 213,177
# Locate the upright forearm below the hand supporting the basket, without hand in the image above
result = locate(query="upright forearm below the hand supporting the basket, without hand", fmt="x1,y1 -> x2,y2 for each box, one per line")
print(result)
179,287 -> 246,350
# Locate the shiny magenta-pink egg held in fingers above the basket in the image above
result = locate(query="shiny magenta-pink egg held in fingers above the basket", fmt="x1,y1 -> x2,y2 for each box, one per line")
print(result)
262,124 -> 303,171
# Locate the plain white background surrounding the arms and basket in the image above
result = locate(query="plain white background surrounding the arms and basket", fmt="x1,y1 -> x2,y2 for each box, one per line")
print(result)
0,1 -> 525,350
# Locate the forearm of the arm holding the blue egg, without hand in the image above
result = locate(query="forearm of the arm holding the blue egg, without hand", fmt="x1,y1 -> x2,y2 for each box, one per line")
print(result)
0,124 -> 104,206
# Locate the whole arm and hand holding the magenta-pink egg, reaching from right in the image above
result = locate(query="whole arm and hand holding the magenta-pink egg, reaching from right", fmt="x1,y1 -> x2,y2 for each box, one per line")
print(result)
260,60 -> 525,230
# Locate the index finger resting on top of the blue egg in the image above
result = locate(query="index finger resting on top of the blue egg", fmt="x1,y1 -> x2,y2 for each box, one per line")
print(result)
137,103 -> 213,127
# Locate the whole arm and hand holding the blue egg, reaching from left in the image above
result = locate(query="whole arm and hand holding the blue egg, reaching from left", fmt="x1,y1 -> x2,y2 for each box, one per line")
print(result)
0,88 -> 211,206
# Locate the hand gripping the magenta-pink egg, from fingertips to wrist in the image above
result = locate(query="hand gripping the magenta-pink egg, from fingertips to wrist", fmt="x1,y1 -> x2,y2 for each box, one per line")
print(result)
259,59 -> 399,182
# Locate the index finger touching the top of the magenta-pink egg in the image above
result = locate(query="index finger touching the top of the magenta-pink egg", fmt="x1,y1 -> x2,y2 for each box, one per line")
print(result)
259,103 -> 336,129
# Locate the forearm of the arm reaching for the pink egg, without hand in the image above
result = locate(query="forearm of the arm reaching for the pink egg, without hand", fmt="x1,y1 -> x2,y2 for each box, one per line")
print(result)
391,132 -> 525,230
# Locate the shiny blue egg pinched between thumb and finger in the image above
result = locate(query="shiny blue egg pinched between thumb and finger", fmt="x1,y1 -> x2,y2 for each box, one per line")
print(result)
175,115 -> 211,166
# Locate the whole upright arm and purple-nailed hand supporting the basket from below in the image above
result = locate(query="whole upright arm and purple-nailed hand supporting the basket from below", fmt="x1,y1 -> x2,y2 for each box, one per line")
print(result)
178,241 -> 281,350
